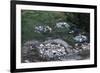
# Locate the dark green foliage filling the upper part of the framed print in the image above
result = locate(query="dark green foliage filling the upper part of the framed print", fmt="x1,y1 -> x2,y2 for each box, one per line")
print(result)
21,10 -> 90,43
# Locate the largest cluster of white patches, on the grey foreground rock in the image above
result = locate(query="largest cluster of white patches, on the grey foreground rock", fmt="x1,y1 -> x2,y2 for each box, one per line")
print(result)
40,42 -> 66,59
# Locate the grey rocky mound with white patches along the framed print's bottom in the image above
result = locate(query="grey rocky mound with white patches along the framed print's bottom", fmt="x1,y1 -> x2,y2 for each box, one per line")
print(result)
22,39 -> 90,62
